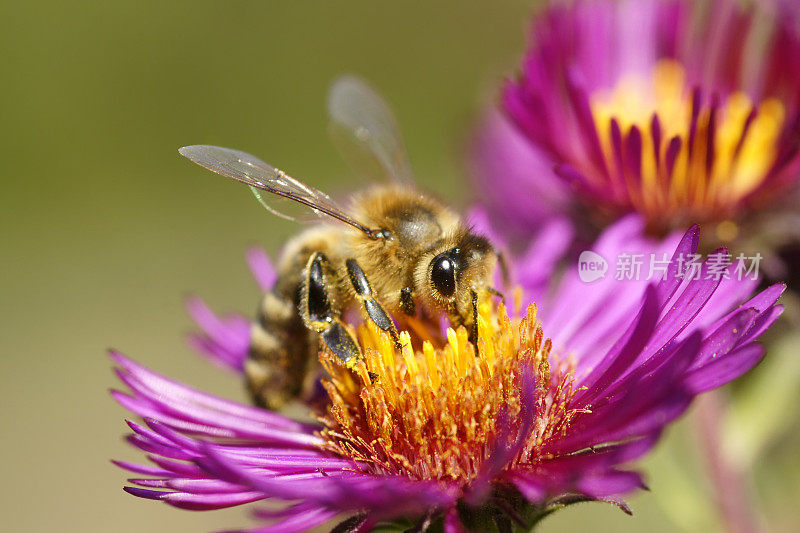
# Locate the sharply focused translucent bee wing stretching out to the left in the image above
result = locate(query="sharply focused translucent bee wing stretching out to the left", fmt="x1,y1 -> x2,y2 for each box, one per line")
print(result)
178,144 -> 377,236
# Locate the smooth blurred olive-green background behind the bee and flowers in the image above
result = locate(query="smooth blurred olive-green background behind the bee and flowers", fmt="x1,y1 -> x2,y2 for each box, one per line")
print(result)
0,0 -> 792,532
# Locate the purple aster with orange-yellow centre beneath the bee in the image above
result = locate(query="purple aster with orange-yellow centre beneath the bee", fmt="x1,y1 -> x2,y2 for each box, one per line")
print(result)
112,218 -> 783,531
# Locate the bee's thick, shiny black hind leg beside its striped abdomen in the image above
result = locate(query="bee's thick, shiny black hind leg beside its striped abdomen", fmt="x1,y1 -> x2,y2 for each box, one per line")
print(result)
300,252 -> 361,367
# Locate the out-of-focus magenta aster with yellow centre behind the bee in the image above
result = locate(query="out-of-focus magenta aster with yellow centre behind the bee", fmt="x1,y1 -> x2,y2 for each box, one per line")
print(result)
500,0 -> 800,241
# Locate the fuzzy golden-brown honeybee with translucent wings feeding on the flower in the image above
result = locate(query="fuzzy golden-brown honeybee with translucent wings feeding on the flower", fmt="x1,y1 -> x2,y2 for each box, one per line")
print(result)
179,77 -> 501,409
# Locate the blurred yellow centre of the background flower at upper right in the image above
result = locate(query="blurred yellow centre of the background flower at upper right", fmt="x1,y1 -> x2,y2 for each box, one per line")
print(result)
591,60 -> 785,235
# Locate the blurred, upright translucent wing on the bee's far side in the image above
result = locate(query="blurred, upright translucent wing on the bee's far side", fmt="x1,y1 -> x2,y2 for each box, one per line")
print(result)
328,76 -> 413,184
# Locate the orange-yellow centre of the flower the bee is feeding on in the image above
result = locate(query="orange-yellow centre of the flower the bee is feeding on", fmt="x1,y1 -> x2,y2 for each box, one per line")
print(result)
319,300 -> 577,483
